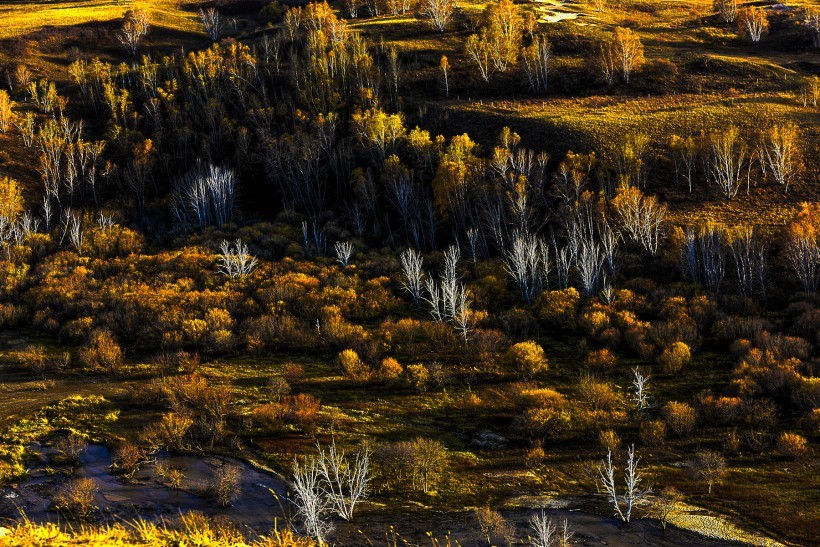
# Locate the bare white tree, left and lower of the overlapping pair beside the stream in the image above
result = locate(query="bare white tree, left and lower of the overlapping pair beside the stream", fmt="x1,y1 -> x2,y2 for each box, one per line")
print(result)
292,458 -> 333,544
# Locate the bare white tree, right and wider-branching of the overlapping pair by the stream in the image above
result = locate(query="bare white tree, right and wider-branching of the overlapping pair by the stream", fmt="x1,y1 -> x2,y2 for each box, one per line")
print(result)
317,440 -> 371,520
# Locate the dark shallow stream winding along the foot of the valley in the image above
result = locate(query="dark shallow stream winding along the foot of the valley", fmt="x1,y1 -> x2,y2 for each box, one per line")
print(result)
0,444 -> 748,547
